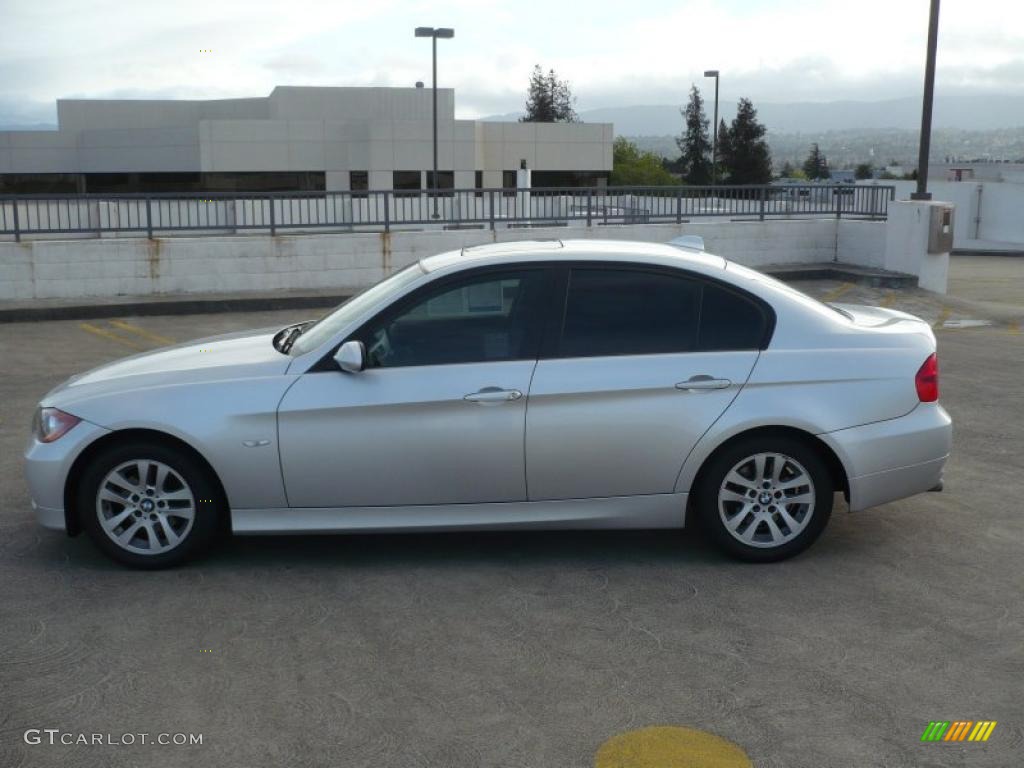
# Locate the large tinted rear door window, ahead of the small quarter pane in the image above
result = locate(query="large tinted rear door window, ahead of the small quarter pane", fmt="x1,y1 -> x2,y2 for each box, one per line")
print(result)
559,269 -> 700,357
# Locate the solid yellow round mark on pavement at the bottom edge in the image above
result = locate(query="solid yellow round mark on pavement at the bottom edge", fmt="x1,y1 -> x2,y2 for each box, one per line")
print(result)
594,725 -> 754,768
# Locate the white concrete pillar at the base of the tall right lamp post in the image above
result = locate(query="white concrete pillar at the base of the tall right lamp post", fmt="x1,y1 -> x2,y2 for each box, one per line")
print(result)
883,200 -> 952,293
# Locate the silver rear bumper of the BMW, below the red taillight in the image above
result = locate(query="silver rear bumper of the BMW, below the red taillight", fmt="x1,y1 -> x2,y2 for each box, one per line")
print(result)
819,402 -> 952,512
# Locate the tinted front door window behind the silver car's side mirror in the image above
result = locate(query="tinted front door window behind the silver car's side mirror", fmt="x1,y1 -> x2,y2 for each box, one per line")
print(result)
364,270 -> 546,368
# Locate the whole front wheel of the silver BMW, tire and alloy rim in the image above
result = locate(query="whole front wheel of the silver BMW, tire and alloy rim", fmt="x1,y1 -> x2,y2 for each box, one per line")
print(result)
76,441 -> 227,569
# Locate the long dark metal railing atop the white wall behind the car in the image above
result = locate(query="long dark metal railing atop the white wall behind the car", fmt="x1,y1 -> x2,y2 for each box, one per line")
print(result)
0,184 -> 895,240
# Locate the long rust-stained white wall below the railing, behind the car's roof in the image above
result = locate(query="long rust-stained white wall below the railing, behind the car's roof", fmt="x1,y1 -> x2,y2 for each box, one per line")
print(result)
0,219 -> 856,300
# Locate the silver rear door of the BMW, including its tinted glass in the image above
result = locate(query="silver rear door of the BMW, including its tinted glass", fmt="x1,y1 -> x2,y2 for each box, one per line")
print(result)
526,264 -> 770,500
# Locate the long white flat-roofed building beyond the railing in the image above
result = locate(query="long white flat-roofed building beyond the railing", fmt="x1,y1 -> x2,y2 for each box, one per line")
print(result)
0,87 -> 612,193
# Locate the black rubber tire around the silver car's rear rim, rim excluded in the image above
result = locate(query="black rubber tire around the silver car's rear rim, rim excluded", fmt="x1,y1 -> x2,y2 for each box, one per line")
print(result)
694,435 -> 836,562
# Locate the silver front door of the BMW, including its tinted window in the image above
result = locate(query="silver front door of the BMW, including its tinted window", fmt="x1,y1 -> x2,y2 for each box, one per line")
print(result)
279,267 -> 550,507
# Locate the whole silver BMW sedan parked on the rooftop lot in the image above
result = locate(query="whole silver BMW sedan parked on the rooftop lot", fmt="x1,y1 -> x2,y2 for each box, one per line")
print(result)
26,241 -> 951,567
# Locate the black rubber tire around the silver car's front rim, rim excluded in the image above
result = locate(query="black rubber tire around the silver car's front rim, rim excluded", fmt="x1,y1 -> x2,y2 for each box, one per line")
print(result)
76,442 -> 222,568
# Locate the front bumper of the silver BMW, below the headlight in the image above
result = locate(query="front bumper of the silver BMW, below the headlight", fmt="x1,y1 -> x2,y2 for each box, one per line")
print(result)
25,421 -> 110,530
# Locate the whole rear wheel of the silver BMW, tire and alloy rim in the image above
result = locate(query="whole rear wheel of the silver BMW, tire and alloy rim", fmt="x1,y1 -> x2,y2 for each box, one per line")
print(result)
695,435 -> 836,562
